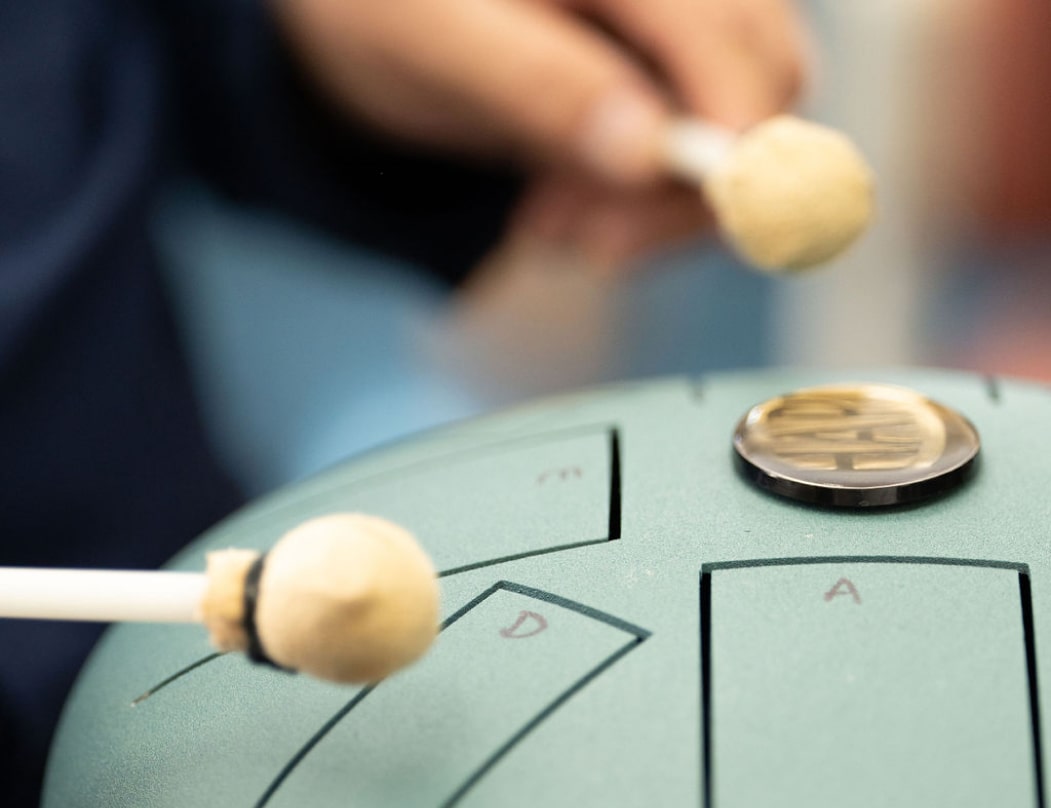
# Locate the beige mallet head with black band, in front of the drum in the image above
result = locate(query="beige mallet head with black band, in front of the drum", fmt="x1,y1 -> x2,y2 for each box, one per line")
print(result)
201,514 -> 439,683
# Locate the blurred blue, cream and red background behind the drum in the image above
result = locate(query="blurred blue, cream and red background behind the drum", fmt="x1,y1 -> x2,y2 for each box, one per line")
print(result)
157,0 -> 1051,494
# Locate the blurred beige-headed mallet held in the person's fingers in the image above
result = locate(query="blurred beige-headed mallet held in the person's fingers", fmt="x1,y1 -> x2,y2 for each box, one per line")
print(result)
663,116 -> 873,270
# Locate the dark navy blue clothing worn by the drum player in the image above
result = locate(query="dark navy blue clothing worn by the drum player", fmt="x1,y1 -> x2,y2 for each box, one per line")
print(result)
0,0 -> 514,808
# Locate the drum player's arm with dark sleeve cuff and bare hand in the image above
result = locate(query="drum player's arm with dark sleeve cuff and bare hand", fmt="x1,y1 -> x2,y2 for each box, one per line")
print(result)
159,0 -> 804,278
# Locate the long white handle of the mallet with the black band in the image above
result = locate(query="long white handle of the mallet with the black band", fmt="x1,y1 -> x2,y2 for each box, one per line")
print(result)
0,567 -> 207,623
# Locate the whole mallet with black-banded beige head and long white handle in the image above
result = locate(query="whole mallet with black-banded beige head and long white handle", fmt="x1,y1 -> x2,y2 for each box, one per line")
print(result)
0,514 -> 439,682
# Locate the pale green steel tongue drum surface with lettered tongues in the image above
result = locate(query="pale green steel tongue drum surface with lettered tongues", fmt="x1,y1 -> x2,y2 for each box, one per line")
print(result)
44,371 -> 1051,808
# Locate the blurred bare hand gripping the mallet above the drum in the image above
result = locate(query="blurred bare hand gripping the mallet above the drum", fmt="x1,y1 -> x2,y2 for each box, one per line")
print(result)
276,0 -> 804,266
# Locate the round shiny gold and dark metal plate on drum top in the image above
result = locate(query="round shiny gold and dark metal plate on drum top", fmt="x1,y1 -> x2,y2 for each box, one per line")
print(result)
734,385 -> 980,507
